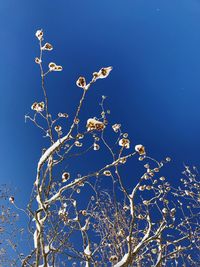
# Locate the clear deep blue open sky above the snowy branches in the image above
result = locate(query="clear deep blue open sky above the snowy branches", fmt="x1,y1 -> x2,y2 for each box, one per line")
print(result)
0,0 -> 200,205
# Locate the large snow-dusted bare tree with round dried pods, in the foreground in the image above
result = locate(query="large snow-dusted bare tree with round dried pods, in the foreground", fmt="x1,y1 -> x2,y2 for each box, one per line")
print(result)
8,30 -> 200,267
